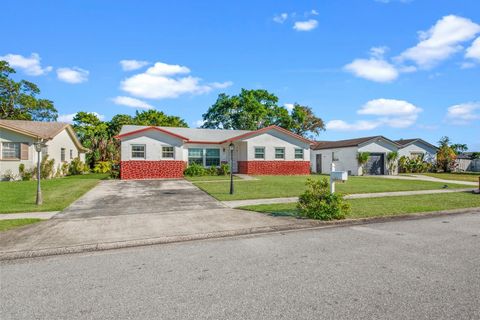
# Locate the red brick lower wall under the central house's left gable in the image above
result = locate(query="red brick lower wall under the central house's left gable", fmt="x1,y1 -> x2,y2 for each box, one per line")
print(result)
120,160 -> 186,179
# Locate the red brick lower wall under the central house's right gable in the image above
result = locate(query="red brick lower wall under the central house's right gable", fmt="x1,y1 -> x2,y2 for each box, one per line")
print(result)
238,161 -> 310,175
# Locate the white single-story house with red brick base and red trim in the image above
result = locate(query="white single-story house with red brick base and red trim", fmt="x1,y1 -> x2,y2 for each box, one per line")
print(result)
116,125 -> 312,179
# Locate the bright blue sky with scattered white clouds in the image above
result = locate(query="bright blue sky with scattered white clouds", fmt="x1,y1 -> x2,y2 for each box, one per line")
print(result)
0,0 -> 480,151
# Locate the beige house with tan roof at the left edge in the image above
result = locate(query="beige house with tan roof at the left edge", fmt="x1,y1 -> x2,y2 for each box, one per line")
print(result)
0,120 -> 87,179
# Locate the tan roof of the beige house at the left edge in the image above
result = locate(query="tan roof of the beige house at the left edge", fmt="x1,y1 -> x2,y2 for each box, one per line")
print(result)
0,120 -> 88,151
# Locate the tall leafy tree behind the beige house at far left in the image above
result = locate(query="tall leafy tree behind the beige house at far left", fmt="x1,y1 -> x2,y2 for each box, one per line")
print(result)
0,60 -> 58,121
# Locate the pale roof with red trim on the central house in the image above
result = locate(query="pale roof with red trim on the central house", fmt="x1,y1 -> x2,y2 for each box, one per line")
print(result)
116,125 -> 311,144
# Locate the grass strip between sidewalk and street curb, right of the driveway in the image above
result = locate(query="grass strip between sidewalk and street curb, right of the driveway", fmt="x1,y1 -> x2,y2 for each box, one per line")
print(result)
241,192 -> 480,219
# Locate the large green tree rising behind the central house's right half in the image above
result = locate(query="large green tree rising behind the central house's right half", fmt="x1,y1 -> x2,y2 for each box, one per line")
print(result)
202,89 -> 324,136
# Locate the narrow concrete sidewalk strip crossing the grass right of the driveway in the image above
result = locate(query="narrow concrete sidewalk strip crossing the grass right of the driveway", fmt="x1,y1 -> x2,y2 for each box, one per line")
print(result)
223,188 -> 473,208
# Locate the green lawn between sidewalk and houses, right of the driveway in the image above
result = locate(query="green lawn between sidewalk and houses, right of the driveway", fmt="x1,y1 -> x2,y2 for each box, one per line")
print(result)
194,175 -> 465,200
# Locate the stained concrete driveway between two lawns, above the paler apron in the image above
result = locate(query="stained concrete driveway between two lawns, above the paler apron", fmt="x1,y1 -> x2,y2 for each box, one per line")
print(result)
54,180 -> 225,219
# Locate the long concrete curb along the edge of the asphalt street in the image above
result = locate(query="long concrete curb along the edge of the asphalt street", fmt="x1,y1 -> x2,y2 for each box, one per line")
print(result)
0,207 -> 480,261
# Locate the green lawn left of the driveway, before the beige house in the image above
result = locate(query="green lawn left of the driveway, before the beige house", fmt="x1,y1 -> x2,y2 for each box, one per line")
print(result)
0,174 -> 107,213
